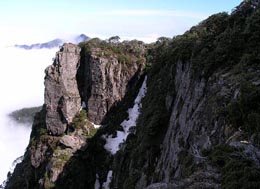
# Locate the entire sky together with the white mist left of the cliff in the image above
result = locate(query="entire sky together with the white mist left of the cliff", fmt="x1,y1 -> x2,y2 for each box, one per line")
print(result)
0,0 -> 244,184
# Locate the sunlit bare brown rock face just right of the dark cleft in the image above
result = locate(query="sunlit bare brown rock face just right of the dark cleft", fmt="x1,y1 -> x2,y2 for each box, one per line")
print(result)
84,49 -> 139,124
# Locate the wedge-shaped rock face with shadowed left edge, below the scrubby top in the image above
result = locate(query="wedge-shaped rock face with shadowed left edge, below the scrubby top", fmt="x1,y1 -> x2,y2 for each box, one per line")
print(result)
79,43 -> 144,124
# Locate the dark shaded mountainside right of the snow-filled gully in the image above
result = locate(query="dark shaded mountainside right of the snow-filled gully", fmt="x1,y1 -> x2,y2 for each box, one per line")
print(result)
112,3 -> 260,189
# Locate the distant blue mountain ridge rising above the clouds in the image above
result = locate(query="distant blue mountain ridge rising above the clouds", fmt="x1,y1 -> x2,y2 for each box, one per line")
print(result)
15,34 -> 90,50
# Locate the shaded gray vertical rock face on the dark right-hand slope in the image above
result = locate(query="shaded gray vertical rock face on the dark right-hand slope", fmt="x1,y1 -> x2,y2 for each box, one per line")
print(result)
153,62 -> 231,185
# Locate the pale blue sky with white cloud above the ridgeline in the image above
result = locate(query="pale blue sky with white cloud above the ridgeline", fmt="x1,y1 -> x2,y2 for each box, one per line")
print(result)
0,0 -> 242,43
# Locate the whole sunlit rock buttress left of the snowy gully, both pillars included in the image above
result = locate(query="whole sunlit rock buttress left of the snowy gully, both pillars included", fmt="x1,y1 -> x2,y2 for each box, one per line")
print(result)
4,39 -> 144,188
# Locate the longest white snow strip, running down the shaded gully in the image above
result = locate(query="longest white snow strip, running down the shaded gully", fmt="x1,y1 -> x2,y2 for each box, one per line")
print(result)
103,77 -> 147,155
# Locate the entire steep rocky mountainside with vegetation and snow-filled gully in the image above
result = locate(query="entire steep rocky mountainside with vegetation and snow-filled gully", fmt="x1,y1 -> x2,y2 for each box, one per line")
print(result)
3,1 -> 260,189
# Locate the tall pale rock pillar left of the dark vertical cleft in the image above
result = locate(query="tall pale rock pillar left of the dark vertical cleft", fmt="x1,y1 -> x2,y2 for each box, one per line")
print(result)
44,44 -> 81,135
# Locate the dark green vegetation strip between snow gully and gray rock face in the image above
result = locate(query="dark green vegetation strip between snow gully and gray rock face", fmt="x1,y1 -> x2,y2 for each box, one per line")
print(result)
111,39 -> 175,188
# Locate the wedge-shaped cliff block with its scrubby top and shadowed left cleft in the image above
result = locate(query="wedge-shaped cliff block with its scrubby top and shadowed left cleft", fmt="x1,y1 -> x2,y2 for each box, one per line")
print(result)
78,40 -> 145,124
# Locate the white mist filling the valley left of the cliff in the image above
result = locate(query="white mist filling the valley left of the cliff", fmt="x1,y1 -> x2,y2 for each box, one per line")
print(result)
0,47 -> 58,184
